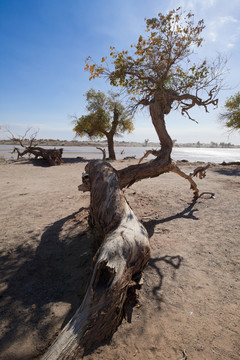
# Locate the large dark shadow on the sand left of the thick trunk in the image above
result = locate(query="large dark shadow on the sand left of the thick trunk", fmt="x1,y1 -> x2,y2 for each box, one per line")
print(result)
0,208 -> 95,360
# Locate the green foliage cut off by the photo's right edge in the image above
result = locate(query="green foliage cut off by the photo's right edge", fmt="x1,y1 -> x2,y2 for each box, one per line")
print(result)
220,92 -> 240,130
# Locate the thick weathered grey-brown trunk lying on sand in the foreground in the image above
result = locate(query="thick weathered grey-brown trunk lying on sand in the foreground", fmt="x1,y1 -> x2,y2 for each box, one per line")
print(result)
42,160 -> 150,360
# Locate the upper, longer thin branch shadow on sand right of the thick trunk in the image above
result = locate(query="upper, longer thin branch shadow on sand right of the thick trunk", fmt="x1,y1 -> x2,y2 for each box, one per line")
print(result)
141,199 -> 199,238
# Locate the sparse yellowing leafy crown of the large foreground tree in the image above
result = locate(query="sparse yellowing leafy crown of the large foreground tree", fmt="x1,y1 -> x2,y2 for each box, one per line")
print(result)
85,8 -> 225,120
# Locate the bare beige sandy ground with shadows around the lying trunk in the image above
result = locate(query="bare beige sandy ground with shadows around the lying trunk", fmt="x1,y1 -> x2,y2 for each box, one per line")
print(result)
0,155 -> 240,360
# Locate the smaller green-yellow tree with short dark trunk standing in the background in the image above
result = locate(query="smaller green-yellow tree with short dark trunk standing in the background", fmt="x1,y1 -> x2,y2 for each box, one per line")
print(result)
73,89 -> 134,159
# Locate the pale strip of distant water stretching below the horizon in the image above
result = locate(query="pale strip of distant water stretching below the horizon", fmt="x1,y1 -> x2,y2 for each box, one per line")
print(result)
0,145 -> 240,163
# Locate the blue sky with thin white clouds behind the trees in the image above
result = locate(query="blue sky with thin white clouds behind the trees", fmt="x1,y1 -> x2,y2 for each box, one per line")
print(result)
0,0 -> 240,145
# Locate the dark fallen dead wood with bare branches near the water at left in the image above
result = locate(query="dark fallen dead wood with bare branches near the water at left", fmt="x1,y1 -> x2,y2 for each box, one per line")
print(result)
13,146 -> 63,165
